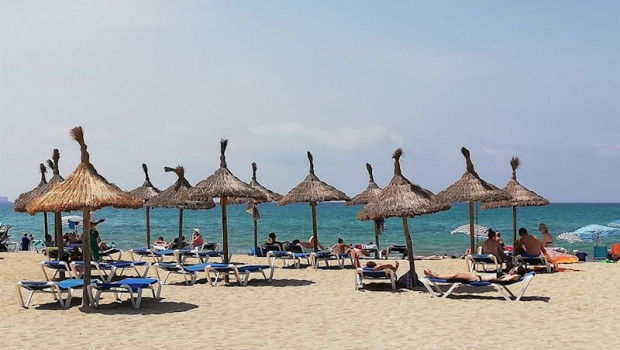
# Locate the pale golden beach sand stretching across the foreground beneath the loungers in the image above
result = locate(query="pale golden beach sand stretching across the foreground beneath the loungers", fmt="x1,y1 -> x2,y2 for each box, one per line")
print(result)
0,252 -> 620,349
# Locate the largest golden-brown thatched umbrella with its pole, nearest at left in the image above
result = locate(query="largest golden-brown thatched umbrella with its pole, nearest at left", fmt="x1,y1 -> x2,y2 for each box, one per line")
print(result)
26,127 -> 142,306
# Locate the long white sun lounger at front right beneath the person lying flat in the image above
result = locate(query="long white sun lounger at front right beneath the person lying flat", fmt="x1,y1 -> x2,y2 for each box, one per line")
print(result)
420,272 -> 536,301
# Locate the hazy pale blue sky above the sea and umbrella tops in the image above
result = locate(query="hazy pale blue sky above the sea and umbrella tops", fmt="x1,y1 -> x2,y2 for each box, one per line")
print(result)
0,0 -> 620,202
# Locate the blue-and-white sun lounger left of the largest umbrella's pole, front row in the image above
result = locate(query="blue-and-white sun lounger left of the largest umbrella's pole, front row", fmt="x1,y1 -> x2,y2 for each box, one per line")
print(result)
17,278 -> 92,308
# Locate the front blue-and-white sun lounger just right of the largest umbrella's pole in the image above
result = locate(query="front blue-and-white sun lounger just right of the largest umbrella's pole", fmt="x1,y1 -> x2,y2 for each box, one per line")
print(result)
88,278 -> 162,309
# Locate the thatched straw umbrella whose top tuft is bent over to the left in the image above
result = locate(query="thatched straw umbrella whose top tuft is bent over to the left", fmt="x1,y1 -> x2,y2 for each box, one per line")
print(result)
148,165 -> 215,242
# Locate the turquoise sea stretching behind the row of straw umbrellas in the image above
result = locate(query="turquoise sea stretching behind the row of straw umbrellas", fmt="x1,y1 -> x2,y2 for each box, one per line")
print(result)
0,203 -> 620,256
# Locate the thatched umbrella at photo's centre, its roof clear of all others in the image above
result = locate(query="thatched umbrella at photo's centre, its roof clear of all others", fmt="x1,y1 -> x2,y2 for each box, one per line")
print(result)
278,151 -> 351,252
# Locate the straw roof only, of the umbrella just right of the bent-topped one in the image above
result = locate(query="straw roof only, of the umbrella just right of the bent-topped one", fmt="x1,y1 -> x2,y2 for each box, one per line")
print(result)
189,139 -> 267,201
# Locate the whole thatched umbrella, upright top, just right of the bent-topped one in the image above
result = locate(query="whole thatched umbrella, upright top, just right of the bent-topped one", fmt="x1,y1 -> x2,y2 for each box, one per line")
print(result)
189,139 -> 267,266
